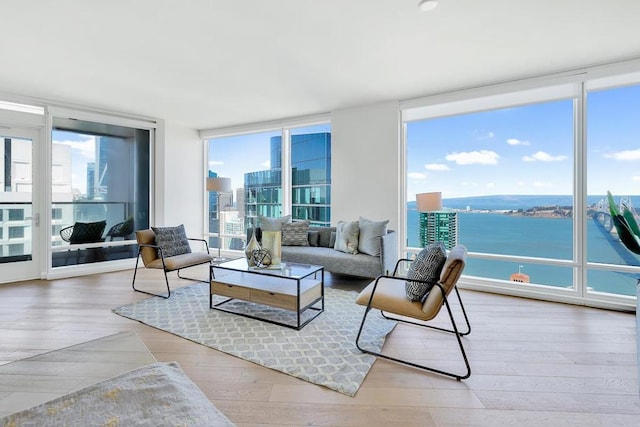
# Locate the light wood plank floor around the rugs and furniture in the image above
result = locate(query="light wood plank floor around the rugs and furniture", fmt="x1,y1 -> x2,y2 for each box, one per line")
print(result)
0,269 -> 640,427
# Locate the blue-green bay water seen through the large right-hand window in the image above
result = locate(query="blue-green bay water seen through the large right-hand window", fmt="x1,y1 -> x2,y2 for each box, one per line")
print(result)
407,209 -> 640,295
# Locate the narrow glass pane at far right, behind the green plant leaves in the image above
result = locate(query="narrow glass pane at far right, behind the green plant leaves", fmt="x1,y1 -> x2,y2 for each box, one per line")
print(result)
585,84 -> 640,295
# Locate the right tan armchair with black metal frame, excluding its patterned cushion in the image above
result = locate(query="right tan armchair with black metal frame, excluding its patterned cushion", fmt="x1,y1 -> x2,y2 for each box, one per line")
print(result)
356,245 -> 471,380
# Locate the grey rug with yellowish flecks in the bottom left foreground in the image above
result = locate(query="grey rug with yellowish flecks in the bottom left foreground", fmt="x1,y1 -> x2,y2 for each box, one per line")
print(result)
0,362 -> 233,427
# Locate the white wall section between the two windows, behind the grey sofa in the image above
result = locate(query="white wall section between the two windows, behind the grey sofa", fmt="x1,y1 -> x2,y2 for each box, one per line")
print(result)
331,102 -> 401,230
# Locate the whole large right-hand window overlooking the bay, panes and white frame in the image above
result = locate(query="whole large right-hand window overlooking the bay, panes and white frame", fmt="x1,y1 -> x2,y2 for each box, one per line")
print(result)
403,72 -> 640,304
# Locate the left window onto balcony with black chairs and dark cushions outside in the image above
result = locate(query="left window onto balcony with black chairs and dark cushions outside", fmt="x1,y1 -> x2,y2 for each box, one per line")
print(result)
51,116 -> 152,267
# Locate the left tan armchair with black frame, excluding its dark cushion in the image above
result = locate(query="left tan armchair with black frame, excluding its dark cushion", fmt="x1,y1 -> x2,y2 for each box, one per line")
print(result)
131,229 -> 213,298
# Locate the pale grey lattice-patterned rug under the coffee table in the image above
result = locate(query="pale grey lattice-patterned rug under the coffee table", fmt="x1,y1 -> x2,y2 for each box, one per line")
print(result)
113,283 -> 396,396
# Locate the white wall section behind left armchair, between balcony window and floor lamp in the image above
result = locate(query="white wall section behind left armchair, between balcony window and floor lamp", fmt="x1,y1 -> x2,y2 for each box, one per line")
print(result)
156,121 -> 205,238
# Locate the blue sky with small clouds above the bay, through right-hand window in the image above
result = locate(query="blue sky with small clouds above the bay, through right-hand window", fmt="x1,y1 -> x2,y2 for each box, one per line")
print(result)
407,86 -> 640,200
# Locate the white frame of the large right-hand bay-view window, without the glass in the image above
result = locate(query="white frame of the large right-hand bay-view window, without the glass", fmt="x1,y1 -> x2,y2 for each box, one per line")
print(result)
399,71 -> 640,309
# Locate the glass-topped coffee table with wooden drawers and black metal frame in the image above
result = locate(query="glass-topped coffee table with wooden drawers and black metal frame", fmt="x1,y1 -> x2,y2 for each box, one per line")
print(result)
209,258 -> 324,330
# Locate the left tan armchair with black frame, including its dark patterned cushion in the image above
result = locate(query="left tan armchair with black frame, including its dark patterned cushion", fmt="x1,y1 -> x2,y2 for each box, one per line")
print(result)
131,225 -> 213,298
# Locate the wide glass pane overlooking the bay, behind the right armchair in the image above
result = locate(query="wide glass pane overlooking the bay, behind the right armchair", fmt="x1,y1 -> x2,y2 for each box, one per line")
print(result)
406,99 -> 574,287
